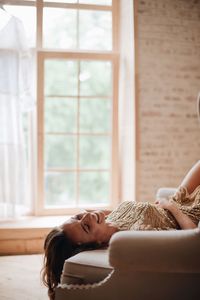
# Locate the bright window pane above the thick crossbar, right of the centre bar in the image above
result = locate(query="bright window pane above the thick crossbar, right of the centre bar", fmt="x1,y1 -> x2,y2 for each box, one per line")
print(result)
79,10 -> 112,50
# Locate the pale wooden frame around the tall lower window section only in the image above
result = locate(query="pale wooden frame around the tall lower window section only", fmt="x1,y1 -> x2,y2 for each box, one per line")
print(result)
36,51 -> 119,215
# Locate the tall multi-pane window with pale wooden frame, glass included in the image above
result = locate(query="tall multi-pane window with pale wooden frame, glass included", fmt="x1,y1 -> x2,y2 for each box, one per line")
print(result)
4,0 -> 119,215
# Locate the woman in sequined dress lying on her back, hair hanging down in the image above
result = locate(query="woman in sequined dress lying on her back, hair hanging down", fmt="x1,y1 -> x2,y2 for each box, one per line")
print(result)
43,161 -> 200,299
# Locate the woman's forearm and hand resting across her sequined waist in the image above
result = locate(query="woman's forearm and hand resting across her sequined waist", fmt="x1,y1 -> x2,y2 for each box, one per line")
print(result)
156,198 -> 197,229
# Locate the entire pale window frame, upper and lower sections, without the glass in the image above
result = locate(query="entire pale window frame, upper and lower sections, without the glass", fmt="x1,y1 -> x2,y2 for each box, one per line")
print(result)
1,0 -> 120,215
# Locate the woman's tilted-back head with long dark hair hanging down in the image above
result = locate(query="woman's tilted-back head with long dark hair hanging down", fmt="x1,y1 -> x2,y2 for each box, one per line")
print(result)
42,211 -> 117,299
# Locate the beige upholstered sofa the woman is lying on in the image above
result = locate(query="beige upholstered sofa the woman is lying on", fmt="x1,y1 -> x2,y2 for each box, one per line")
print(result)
56,191 -> 200,300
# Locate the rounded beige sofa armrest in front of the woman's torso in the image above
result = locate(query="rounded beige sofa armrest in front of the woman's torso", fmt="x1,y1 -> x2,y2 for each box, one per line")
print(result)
109,227 -> 200,273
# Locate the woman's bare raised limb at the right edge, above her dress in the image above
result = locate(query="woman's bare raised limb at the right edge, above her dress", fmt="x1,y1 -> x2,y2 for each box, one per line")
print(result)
181,161 -> 200,194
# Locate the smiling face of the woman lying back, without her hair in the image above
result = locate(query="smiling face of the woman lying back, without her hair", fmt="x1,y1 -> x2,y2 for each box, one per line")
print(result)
61,213 -> 117,244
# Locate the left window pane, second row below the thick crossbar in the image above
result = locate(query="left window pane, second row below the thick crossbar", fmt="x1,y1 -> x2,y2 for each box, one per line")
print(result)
45,98 -> 77,132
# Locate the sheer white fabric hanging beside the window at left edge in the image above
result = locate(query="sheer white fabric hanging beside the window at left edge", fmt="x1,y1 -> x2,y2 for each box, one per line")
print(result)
0,12 -> 34,219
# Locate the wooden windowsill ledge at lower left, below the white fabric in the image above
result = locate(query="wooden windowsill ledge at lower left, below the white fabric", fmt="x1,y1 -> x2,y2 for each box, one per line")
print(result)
0,215 -> 70,255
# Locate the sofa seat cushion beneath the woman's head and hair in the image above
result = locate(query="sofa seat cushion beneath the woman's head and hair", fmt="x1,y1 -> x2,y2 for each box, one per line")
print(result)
61,249 -> 112,284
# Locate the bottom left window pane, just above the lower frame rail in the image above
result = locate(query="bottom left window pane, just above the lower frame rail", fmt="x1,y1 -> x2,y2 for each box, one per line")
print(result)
45,173 -> 76,207
